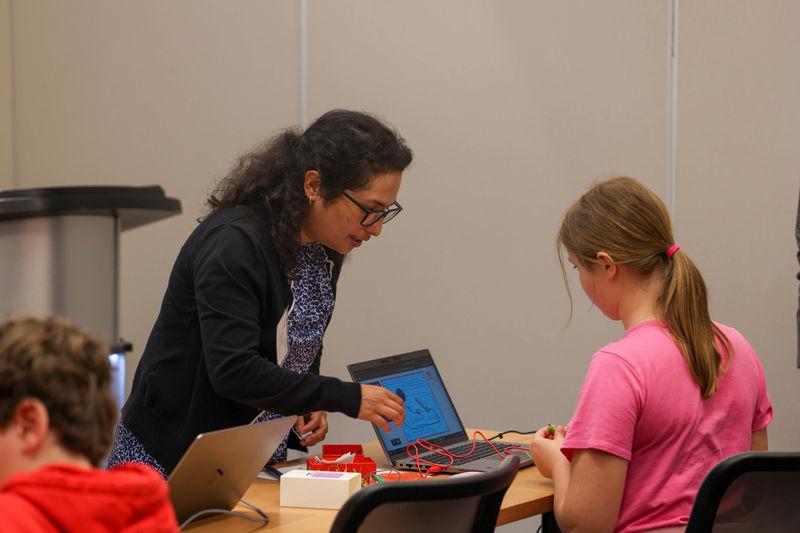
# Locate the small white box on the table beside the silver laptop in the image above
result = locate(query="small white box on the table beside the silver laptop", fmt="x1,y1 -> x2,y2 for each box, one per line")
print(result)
281,470 -> 361,509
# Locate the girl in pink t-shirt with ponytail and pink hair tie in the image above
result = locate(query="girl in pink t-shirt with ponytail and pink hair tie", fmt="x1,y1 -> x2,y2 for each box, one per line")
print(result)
531,177 -> 772,532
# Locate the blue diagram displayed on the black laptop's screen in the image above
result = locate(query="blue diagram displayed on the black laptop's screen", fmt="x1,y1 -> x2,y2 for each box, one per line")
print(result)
383,372 -> 447,442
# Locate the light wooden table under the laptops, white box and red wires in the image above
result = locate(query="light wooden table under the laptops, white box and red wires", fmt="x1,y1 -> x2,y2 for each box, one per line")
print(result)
186,429 -> 553,533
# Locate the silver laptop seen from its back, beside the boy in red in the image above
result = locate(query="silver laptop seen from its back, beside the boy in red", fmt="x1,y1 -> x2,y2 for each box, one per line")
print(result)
167,416 -> 297,523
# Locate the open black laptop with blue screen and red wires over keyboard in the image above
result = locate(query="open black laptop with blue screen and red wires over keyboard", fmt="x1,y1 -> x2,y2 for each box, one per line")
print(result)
347,350 -> 533,473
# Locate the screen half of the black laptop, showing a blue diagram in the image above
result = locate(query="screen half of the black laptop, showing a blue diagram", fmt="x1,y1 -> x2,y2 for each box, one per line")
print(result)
348,350 -> 466,457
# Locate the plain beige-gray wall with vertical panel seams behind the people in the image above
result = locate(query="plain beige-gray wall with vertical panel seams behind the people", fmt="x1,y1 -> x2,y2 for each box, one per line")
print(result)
0,0 -> 800,528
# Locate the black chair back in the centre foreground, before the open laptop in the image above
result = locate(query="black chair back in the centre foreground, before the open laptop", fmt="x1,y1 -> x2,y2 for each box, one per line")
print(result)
331,456 -> 519,533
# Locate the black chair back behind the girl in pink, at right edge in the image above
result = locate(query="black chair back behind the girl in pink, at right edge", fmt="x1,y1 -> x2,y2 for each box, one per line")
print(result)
686,452 -> 800,533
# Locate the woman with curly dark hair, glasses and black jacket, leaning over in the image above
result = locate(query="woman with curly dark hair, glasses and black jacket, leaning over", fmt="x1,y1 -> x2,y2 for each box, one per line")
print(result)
109,110 -> 412,477
